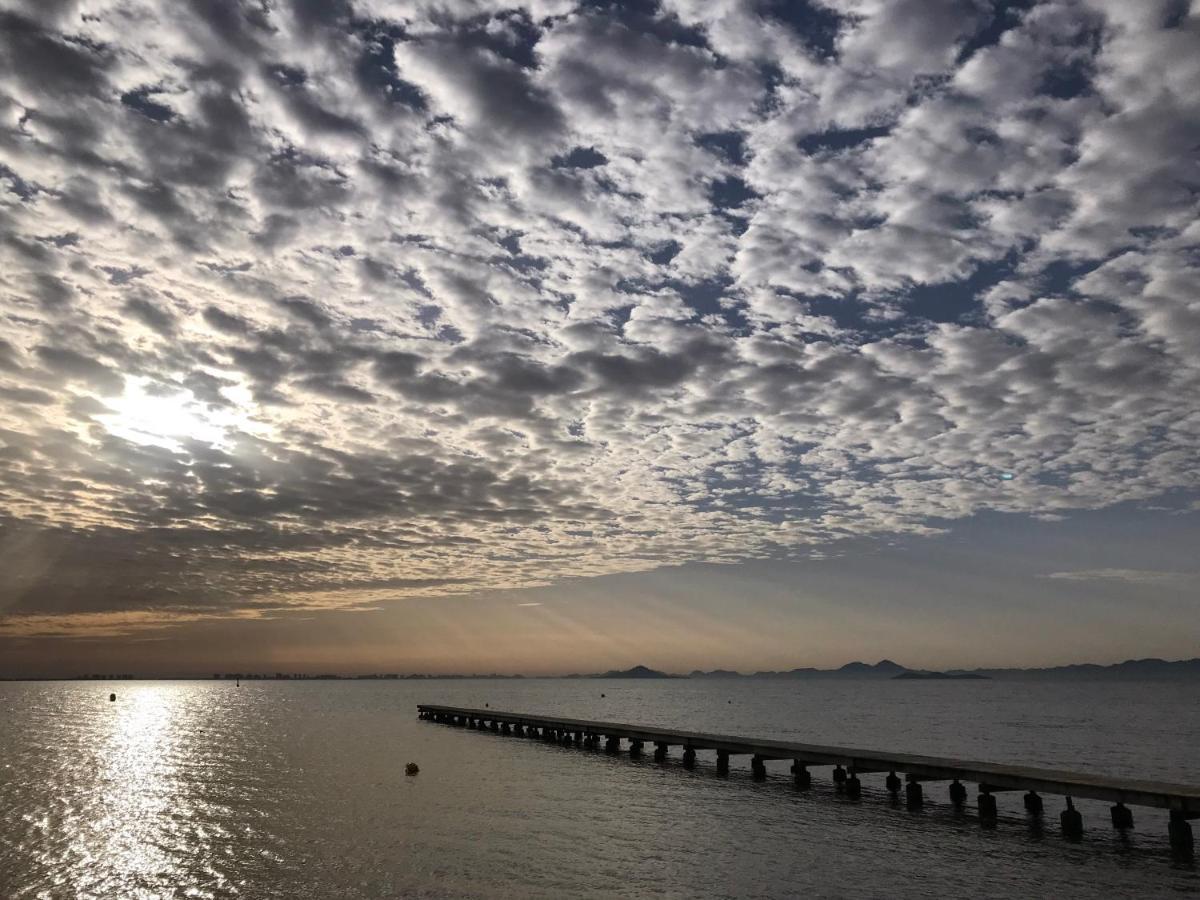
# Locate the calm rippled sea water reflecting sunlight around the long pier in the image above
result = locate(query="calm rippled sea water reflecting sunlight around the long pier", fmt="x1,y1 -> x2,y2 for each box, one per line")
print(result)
0,680 -> 1200,900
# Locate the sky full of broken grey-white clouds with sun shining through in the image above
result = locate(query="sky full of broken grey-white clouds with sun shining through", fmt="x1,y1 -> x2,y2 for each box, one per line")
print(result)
0,0 -> 1200,674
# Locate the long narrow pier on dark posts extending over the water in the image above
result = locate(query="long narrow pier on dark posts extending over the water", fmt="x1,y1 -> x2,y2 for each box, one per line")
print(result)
416,703 -> 1200,853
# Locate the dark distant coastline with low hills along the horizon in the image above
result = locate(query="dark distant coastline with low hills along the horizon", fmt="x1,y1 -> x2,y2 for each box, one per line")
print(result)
0,659 -> 1200,682
